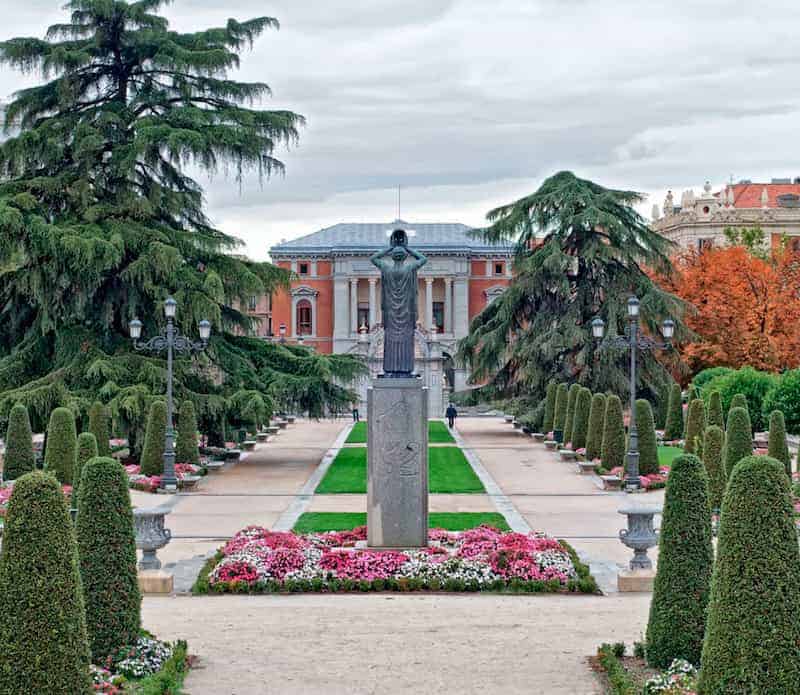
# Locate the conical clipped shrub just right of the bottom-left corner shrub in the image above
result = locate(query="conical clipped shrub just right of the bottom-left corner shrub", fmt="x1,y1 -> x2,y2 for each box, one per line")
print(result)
75,457 -> 142,661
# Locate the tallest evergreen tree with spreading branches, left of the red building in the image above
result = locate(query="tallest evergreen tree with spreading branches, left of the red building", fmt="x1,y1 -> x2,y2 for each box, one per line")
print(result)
0,0 -> 361,438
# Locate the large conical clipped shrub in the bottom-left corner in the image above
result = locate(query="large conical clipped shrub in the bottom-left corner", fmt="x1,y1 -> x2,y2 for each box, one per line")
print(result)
0,471 -> 92,695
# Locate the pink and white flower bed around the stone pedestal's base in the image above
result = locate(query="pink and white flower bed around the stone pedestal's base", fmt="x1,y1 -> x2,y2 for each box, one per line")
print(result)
208,526 -> 578,592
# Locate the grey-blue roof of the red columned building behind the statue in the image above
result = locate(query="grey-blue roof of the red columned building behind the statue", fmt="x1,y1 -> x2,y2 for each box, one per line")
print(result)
270,220 -> 512,256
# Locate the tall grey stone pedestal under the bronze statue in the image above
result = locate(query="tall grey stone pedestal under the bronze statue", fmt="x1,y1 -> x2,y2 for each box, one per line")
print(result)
367,379 -> 428,548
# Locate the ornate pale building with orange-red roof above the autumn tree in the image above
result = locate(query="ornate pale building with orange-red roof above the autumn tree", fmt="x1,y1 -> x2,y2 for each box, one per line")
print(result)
652,177 -> 800,251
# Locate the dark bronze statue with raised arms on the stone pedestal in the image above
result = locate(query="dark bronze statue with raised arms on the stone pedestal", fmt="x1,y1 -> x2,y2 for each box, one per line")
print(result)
370,229 -> 428,379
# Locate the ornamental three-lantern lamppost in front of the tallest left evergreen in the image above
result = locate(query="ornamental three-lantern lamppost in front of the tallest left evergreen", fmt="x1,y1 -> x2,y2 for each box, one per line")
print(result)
128,297 -> 211,492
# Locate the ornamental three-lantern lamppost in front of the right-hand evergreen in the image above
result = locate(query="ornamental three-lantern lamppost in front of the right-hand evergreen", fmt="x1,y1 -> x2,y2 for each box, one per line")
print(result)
592,297 -> 675,492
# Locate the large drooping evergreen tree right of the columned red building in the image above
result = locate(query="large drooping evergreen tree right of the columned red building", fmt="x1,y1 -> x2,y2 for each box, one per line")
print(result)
459,171 -> 684,400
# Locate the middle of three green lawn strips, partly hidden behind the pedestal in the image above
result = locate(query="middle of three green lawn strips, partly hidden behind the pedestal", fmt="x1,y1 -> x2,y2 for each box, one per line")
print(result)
316,446 -> 485,495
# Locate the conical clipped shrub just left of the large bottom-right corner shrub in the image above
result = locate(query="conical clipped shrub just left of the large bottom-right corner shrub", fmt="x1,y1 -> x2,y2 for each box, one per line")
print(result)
646,454 -> 714,669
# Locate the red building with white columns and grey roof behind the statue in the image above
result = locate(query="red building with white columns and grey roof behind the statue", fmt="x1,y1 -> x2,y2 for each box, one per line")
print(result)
258,220 -> 513,412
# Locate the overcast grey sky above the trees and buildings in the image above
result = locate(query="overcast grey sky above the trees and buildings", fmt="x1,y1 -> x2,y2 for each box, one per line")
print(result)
0,0 -> 800,259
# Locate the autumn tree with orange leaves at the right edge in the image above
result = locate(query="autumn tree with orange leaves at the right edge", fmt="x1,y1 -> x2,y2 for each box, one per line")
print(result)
660,246 -> 800,373
